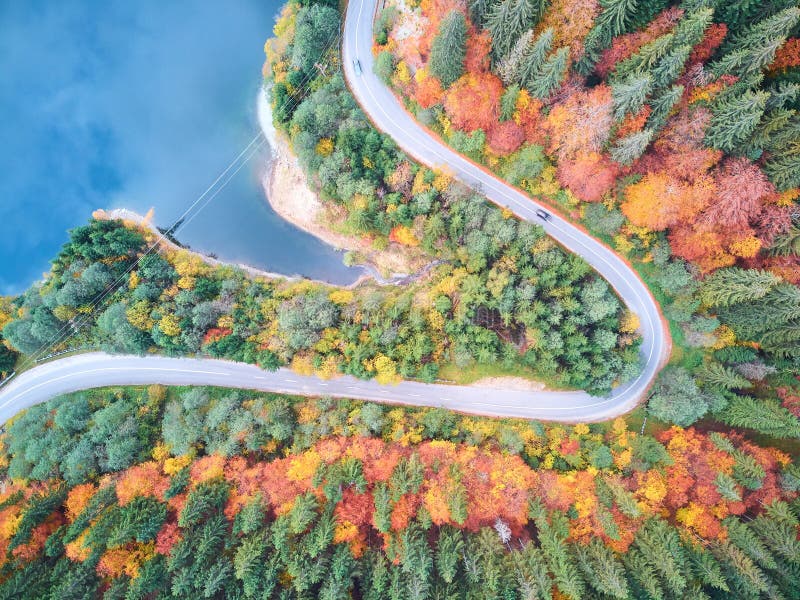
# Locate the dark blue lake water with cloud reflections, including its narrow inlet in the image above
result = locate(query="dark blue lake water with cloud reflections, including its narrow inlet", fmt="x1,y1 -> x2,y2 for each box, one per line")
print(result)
0,0 -> 359,294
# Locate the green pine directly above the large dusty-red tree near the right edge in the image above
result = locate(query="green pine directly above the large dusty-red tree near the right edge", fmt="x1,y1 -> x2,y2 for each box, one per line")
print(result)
706,91 -> 769,152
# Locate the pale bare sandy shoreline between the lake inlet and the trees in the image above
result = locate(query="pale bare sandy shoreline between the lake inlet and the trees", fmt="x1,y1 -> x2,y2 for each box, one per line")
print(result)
258,91 -> 427,279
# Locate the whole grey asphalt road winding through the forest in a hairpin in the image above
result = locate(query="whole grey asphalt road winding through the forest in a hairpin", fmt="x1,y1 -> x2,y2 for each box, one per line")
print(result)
0,0 -> 670,423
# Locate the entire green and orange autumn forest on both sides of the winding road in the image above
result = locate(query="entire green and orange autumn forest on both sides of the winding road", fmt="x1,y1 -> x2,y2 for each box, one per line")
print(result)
0,0 -> 800,600
